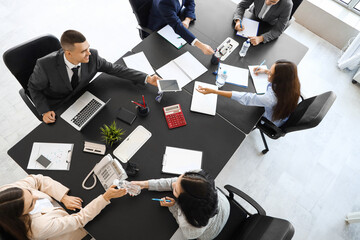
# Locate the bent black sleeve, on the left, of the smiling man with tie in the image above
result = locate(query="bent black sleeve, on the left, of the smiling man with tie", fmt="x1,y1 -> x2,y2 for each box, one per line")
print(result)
28,59 -> 50,115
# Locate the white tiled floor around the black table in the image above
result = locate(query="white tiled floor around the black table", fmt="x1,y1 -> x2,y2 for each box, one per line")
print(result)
0,0 -> 360,240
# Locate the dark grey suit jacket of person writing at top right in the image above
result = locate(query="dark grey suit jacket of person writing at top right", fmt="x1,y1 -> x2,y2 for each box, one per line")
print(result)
234,0 -> 293,43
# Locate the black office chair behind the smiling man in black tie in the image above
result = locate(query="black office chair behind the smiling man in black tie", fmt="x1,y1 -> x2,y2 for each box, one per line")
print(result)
3,35 -> 61,121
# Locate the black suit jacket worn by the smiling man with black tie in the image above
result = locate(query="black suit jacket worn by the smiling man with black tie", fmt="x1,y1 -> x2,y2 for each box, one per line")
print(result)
28,49 -> 147,115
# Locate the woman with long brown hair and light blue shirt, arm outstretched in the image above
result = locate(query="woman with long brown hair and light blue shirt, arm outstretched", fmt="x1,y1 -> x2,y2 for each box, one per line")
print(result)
197,60 -> 300,127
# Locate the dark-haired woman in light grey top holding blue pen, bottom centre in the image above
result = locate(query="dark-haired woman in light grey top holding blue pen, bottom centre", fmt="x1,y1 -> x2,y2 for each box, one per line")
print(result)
132,171 -> 230,240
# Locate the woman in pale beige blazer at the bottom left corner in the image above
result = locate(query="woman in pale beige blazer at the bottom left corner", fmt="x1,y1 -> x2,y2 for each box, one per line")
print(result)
0,175 -> 126,240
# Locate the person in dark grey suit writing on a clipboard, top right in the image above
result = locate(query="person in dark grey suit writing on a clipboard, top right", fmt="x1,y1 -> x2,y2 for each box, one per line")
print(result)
234,0 -> 293,46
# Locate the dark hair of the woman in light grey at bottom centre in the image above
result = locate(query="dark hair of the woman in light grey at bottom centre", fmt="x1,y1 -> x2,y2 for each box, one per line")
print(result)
178,171 -> 218,227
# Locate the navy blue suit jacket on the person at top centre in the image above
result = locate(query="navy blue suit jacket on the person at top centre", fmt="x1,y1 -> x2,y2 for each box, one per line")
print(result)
147,0 -> 196,44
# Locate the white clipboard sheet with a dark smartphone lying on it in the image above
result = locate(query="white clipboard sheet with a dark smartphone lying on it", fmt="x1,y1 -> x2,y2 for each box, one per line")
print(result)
27,142 -> 74,170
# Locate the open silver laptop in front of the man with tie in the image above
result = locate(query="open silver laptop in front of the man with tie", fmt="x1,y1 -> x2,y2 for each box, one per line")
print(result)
60,92 -> 110,131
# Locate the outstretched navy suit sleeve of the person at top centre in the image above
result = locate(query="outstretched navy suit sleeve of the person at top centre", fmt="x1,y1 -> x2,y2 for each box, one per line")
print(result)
159,0 -> 196,44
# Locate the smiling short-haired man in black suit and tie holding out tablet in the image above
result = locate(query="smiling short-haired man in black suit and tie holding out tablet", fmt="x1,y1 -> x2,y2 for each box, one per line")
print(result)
28,30 -> 160,123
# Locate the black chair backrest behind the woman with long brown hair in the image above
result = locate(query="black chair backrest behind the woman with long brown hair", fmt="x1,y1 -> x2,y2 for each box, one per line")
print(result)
280,91 -> 336,133
